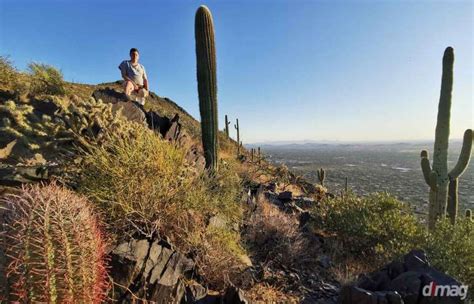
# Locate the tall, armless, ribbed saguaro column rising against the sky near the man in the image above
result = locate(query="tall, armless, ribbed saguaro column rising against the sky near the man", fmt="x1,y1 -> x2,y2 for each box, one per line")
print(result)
195,5 -> 218,170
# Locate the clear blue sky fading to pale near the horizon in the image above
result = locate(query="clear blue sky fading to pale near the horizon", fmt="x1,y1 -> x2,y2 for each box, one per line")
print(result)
0,0 -> 474,144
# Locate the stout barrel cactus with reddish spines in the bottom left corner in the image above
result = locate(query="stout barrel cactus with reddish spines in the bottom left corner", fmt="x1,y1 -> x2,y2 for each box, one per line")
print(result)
0,184 -> 107,303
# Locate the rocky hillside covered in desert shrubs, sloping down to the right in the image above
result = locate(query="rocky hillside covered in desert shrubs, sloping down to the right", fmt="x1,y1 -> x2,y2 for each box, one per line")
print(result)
0,47 -> 474,304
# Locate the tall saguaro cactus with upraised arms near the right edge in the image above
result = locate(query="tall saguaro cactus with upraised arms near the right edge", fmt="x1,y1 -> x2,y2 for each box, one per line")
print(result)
421,47 -> 473,229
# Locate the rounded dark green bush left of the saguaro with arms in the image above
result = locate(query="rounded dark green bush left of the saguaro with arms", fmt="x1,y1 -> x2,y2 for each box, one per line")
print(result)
312,192 -> 425,261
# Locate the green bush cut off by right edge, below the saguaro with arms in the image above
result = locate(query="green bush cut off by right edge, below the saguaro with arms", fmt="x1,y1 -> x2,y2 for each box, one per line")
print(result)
424,218 -> 474,295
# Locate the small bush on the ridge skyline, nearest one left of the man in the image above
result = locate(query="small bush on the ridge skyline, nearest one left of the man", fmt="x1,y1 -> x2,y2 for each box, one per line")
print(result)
28,62 -> 66,95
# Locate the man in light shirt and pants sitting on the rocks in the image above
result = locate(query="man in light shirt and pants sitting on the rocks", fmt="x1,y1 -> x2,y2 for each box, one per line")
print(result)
119,48 -> 148,105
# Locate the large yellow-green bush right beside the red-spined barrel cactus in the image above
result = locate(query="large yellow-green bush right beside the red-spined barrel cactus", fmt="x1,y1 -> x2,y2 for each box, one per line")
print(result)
78,125 -> 193,235
